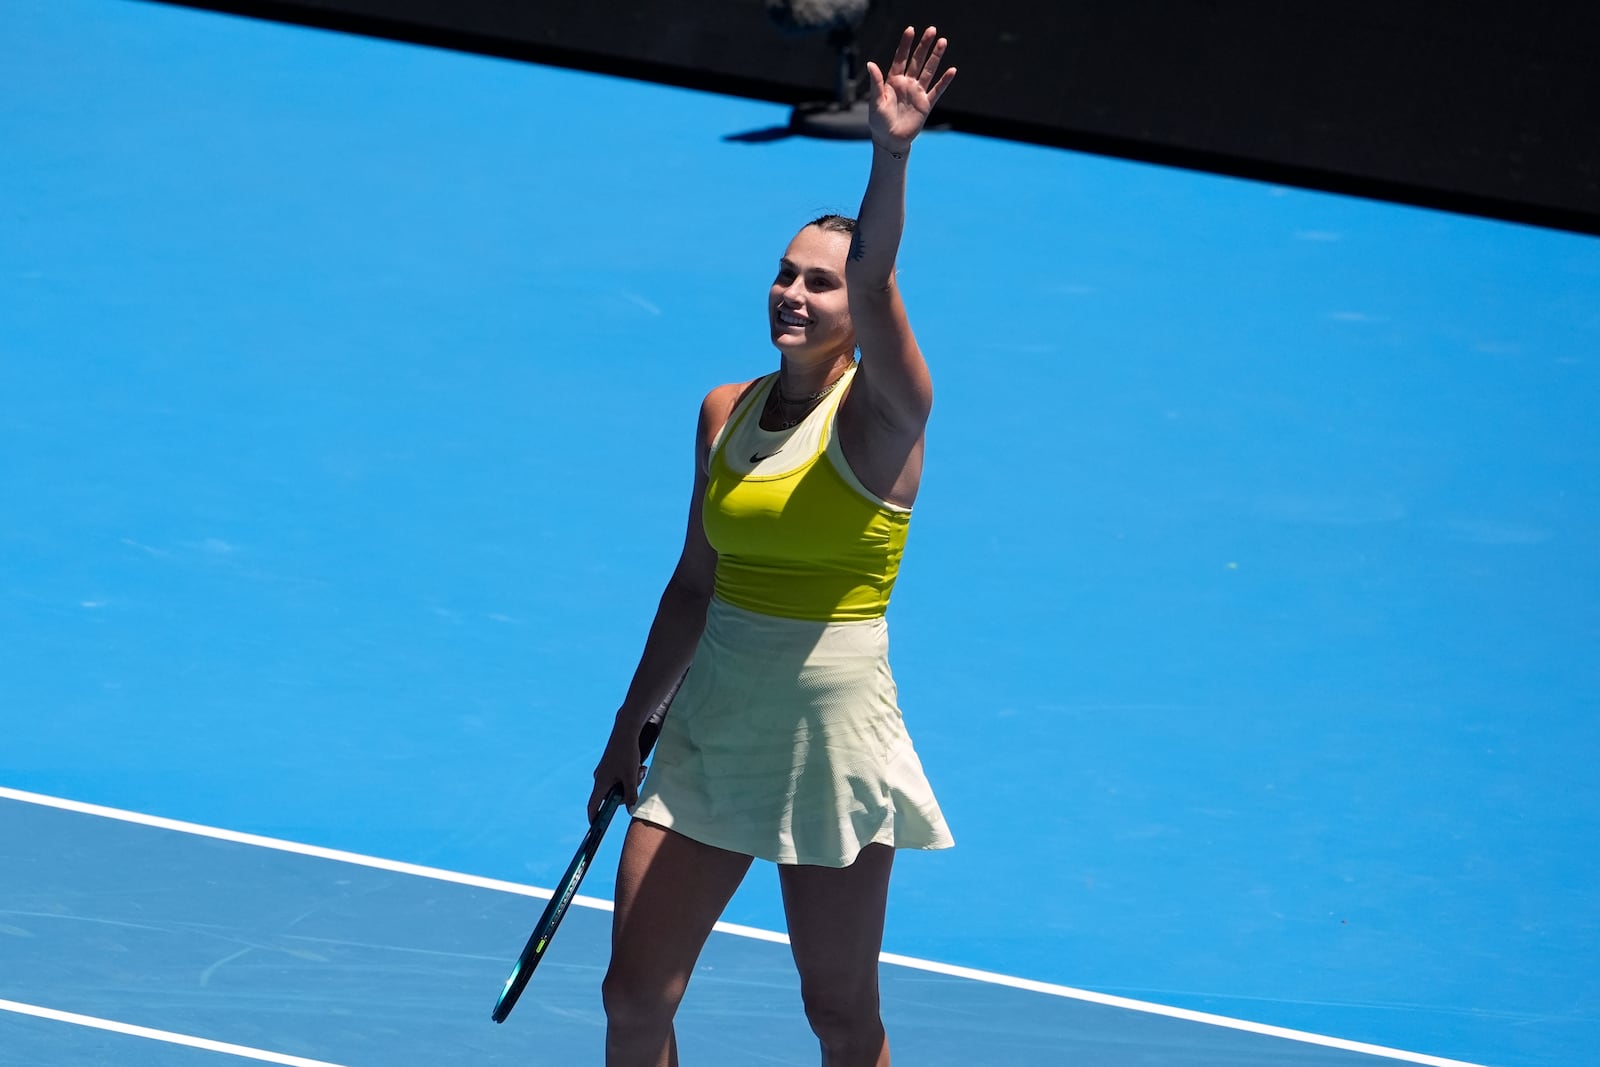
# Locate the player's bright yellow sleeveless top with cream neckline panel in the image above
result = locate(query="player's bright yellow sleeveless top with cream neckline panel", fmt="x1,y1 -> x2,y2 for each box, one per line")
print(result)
704,368 -> 910,622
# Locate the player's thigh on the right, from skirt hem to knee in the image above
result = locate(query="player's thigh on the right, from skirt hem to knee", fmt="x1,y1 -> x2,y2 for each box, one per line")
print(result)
778,845 -> 894,990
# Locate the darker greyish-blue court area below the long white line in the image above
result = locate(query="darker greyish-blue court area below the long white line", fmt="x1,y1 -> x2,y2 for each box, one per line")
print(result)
0,798 -> 1484,1067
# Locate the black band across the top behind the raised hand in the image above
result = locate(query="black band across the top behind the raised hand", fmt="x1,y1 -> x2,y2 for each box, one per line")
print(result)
144,0 -> 1600,234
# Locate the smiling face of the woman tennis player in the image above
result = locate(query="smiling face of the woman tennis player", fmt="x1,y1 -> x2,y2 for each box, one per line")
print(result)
766,226 -> 856,363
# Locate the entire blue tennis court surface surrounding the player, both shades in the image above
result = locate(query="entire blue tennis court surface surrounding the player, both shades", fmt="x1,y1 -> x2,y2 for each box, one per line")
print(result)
0,0 -> 1600,1067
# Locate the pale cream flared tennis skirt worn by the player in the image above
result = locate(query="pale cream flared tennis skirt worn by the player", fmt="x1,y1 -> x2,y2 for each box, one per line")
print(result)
634,598 -> 955,867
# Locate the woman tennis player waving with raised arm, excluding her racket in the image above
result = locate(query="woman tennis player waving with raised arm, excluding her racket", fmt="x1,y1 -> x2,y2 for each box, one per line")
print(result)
589,27 -> 955,1067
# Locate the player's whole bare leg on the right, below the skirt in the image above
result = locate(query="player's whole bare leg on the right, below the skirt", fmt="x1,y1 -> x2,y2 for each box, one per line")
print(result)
778,845 -> 894,1067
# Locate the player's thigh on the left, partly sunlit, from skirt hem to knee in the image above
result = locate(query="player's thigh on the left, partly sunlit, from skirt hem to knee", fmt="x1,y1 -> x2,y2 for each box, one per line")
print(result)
611,819 -> 750,992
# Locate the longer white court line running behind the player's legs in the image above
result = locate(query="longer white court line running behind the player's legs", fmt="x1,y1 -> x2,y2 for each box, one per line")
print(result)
0,785 -> 1483,1067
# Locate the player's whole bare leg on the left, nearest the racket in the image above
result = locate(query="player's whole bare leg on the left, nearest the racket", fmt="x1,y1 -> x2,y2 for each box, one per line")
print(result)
602,819 -> 750,1067
